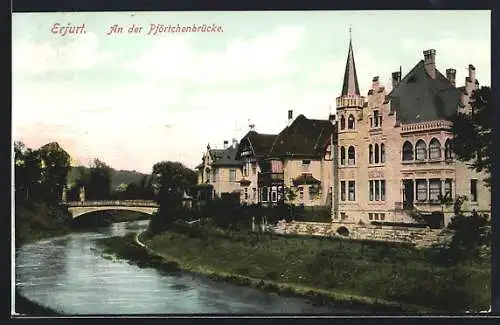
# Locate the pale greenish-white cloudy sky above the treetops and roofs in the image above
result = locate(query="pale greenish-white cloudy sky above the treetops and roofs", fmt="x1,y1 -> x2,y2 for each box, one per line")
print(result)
12,11 -> 491,173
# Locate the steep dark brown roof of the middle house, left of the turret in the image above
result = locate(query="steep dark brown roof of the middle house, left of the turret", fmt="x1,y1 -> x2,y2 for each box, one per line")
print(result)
268,114 -> 333,158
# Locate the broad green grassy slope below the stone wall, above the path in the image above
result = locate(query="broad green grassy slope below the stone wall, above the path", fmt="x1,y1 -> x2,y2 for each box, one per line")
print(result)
138,224 -> 491,312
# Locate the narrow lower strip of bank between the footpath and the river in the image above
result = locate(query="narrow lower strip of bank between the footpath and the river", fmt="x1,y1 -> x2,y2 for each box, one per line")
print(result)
99,229 -> 464,314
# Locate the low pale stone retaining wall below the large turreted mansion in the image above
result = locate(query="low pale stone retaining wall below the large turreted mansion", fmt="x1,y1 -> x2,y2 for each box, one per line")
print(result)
276,220 -> 441,246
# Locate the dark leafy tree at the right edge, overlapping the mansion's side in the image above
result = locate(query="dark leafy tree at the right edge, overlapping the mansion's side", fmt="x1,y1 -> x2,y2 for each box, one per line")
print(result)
452,87 -> 494,186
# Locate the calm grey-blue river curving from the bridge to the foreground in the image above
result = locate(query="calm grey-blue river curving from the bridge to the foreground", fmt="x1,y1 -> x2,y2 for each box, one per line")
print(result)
15,220 -> 357,315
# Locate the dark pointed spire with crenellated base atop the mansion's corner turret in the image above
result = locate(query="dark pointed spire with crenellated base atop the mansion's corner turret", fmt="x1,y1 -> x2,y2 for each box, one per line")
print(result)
336,28 -> 364,115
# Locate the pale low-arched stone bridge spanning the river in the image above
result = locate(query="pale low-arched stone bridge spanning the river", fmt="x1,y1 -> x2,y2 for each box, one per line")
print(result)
63,200 -> 159,219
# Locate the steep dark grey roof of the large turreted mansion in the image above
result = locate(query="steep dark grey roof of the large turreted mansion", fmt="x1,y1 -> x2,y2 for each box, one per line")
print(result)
389,60 -> 460,123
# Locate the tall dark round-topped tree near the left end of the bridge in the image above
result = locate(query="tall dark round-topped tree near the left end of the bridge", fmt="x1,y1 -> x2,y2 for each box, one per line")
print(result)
38,142 -> 71,202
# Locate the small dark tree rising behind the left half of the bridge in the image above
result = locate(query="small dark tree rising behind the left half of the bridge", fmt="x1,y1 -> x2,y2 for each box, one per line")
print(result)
86,158 -> 111,200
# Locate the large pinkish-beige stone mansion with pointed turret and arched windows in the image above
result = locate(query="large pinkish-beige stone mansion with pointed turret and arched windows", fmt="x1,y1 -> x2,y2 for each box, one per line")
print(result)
332,35 -> 491,225
